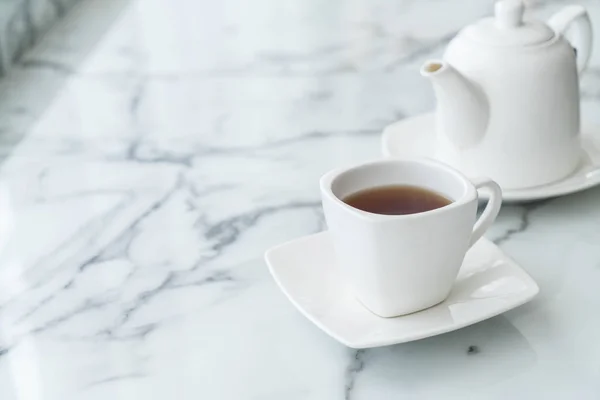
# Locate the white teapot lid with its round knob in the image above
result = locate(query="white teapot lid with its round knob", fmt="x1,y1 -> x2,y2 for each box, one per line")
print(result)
460,0 -> 555,46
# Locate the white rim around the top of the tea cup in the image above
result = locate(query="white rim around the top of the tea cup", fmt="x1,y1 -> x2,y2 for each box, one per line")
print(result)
319,158 -> 477,221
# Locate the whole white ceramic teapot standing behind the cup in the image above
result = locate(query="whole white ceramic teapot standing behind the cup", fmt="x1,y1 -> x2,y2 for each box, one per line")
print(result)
421,0 -> 592,189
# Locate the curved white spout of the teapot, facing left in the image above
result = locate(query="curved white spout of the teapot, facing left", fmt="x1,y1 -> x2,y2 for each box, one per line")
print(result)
421,60 -> 489,148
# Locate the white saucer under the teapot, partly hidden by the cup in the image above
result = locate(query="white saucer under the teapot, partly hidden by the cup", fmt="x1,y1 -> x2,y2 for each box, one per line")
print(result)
383,113 -> 600,202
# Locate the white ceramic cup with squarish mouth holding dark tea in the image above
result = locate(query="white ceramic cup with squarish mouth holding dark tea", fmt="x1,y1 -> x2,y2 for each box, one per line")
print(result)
320,159 -> 502,317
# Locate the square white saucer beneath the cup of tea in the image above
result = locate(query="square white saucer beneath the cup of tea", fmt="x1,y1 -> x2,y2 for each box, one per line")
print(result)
265,232 -> 539,349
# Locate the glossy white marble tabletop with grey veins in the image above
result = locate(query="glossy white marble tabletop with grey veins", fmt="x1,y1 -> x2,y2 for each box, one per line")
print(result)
0,0 -> 600,400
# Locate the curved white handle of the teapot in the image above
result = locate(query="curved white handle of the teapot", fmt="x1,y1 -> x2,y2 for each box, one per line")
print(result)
548,5 -> 592,73
